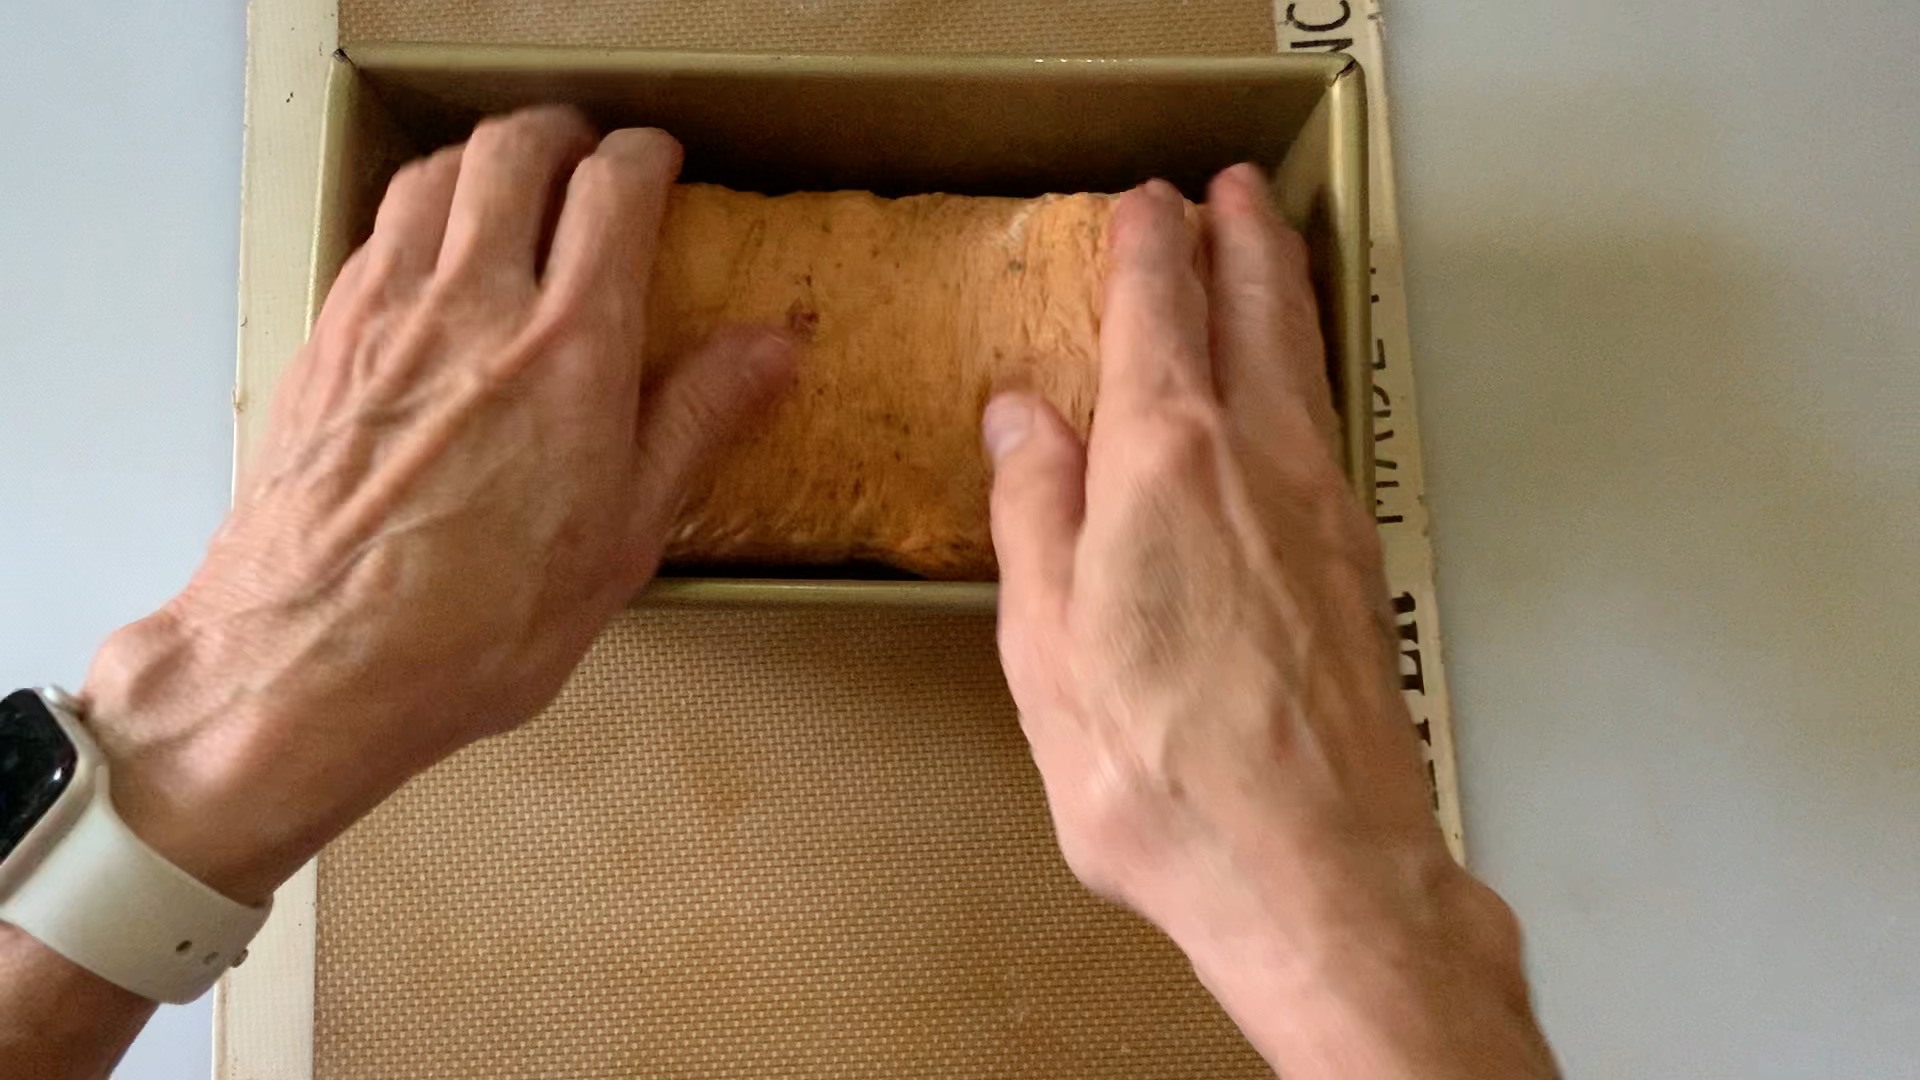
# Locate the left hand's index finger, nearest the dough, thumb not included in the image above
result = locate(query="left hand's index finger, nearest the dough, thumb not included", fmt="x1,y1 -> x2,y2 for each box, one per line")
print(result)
545,127 -> 682,309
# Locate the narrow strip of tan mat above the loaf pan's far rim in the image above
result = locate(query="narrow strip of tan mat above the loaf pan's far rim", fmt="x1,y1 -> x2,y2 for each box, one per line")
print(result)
340,0 -> 1273,54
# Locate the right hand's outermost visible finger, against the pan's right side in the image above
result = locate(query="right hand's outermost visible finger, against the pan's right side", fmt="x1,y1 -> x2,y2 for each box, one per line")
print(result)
1206,165 -> 1334,440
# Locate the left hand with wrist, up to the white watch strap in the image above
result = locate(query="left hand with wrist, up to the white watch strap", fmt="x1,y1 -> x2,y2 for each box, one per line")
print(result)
86,108 -> 793,901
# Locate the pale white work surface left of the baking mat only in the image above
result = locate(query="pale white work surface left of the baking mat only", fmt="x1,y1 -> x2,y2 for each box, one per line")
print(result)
0,0 -> 246,1080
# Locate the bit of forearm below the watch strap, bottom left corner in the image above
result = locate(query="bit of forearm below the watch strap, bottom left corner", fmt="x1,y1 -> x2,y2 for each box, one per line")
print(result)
0,922 -> 154,1080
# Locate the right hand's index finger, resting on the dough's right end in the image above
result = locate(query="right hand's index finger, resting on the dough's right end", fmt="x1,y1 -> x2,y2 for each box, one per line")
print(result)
1100,181 -> 1213,413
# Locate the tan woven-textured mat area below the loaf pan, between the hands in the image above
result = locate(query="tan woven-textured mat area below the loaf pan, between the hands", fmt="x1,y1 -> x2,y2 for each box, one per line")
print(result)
315,611 -> 1265,1080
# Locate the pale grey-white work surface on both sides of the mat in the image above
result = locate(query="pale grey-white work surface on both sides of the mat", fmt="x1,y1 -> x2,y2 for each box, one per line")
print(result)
0,0 -> 1920,1080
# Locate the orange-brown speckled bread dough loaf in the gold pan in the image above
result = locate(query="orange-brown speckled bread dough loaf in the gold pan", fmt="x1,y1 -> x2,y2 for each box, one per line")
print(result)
647,184 -> 1114,580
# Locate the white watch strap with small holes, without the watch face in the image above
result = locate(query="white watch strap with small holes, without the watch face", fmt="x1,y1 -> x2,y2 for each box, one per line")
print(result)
0,776 -> 273,1003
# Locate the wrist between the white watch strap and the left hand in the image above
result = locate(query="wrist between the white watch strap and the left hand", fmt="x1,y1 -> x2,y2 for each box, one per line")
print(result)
81,607 -> 334,905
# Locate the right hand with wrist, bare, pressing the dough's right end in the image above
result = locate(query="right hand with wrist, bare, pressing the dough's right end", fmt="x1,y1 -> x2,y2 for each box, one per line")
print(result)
983,165 -> 1551,1078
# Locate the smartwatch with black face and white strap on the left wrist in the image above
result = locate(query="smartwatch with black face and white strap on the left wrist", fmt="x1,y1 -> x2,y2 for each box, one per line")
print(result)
0,690 -> 273,1003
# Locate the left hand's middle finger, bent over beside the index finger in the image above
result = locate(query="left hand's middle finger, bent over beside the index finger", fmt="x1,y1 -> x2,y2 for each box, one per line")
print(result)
440,106 -> 593,279
